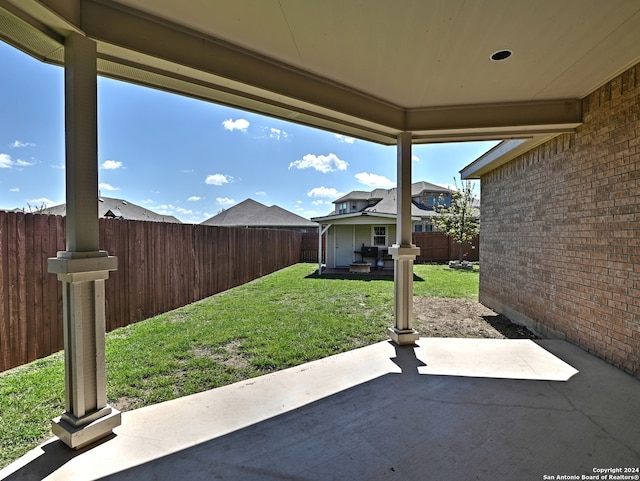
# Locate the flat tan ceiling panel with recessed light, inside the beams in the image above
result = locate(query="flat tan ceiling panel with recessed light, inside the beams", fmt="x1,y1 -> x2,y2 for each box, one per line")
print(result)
112,0 -> 640,109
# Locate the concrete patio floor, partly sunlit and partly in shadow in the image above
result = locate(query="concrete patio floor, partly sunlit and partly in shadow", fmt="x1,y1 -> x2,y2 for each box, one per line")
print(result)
0,338 -> 640,481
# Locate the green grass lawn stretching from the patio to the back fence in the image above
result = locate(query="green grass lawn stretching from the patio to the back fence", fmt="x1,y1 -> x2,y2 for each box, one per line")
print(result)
0,264 -> 478,467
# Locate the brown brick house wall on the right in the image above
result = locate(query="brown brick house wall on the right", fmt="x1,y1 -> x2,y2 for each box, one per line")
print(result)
480,65 -> 640,377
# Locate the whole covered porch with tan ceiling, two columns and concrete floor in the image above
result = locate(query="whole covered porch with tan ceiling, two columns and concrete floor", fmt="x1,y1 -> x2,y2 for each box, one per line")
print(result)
0,0 -> 640,466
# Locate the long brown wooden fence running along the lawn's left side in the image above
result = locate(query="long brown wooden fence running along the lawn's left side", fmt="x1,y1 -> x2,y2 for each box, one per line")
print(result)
0,212 -> 302,372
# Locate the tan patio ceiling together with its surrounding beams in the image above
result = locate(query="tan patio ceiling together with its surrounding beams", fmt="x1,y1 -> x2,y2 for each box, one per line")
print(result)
0,0 -> 640,144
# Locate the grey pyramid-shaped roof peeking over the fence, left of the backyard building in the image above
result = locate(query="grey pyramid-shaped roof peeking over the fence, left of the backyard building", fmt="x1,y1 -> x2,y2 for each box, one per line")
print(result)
202,199 -> 318,232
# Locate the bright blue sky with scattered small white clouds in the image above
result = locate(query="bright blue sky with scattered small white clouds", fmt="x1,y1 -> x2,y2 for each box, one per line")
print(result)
0,41 -> 496,223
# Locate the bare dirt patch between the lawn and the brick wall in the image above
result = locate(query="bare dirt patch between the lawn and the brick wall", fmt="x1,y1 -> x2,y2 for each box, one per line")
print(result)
413,297 -> 537,339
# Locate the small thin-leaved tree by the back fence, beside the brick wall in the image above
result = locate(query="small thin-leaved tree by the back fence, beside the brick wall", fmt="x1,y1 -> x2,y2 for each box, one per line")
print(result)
433,178 -> 480,263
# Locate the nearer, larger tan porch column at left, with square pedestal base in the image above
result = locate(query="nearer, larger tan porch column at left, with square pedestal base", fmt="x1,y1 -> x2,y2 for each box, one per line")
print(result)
48,33 -> 120,449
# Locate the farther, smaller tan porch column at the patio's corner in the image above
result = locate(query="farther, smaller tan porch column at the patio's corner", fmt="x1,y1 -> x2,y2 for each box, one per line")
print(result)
388,132 -> 420,345
